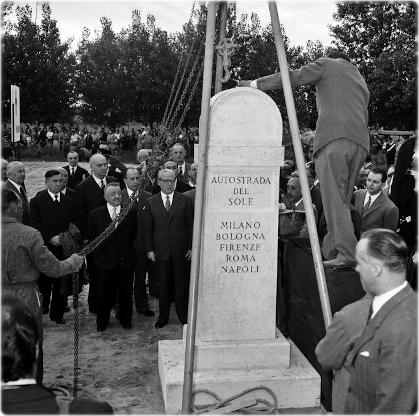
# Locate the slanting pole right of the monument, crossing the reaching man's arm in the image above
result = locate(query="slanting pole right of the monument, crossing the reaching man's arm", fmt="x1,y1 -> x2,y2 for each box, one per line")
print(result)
269,0 -> 332,328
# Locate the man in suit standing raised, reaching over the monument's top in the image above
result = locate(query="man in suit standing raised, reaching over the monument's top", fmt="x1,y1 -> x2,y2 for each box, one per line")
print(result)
238,50 -> 370,267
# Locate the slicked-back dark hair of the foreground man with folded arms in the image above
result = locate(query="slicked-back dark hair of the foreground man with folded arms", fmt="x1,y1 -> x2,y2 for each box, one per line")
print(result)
361,228 -> 408,274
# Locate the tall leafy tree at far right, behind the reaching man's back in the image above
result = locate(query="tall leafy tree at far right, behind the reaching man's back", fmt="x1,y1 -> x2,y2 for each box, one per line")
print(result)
329,5 -> 415,129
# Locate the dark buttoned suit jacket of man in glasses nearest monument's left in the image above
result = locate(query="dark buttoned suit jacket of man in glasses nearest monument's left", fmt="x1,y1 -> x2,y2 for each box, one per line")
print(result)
144,192 -> 193,261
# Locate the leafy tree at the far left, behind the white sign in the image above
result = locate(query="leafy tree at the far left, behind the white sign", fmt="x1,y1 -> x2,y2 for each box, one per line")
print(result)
5,4 -> 75,123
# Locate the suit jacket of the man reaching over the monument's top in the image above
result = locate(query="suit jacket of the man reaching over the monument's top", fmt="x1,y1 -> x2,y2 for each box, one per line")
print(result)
257,58 -> 370,154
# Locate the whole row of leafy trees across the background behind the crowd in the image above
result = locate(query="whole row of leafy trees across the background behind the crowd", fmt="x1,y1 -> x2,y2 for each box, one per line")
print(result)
5,5 -> 415,129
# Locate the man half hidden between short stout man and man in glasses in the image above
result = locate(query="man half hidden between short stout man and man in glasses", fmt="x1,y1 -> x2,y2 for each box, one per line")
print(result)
121,168 -> 157,317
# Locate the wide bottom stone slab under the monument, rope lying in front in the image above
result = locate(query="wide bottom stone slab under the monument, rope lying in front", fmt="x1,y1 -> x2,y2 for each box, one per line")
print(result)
159,340 -> 320,412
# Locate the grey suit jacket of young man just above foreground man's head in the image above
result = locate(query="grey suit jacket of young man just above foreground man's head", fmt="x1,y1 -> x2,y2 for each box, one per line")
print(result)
353,189 -> 399,234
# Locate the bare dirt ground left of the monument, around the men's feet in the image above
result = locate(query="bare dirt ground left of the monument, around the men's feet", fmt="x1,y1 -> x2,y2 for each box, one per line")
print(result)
22,160 -> 182,412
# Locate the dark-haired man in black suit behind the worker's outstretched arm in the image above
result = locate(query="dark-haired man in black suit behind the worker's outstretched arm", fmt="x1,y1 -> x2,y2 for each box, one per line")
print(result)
30,169 -> 73,324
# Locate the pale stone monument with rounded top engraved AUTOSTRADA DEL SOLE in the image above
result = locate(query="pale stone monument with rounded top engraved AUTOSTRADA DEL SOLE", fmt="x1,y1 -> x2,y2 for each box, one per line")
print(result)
159,88 -> 320,412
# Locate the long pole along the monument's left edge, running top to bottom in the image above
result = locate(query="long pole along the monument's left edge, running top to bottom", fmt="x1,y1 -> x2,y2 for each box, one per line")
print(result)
182,0 -> 216,414
